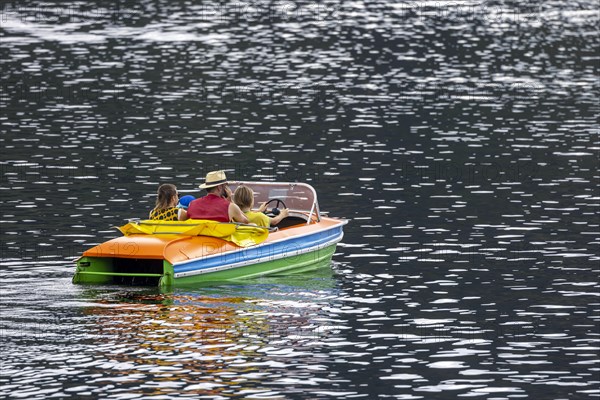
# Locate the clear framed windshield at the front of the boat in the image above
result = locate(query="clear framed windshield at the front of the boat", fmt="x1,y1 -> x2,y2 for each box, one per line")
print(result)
229,181 -> 320,219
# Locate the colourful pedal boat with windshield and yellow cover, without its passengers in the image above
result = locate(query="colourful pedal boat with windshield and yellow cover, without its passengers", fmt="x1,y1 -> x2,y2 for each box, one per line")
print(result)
73,182 -> 348,286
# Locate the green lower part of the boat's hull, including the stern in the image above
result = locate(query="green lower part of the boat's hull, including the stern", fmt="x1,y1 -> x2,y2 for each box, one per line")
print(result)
73,244 -> 336,287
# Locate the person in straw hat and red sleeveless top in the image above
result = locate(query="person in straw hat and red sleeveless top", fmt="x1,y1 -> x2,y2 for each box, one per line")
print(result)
187,171 -> 248,224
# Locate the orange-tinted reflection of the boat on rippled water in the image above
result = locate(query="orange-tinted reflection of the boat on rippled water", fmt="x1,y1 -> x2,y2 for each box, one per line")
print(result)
77,266 -> 343,396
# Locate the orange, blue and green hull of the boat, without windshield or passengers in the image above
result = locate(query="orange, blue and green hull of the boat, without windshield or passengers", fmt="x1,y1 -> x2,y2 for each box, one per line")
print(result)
73,217 -> 347,286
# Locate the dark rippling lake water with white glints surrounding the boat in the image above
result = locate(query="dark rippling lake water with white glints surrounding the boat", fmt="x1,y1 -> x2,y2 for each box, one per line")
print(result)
0,0 -> 600,400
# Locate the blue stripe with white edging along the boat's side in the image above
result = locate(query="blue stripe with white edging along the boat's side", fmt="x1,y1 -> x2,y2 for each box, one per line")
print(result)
173,226 -> 342,274
